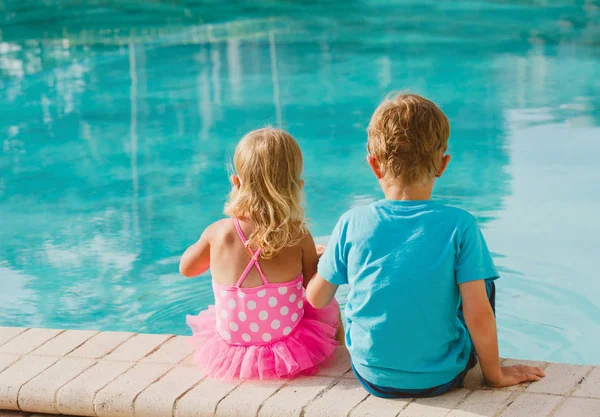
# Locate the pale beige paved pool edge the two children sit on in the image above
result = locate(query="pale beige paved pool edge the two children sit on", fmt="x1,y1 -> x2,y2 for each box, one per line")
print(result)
0,327 -> 600,417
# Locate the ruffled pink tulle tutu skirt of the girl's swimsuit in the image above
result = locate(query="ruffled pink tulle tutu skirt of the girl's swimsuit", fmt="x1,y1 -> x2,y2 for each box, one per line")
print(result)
186,300 -> 340,381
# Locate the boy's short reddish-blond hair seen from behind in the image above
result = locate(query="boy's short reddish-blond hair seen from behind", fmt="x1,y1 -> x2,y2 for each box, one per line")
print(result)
367,94 -> 450,185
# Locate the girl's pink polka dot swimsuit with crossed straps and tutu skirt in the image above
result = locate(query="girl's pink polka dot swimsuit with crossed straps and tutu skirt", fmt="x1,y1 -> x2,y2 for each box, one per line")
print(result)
187,219 -> 339,380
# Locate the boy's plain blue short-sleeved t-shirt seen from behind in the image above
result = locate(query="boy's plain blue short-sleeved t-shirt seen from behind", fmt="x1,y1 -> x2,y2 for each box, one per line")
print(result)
319,200 -> 498,389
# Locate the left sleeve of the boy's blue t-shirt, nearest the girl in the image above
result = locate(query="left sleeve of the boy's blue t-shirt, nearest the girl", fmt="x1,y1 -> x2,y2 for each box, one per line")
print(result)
318,217 -> 348,285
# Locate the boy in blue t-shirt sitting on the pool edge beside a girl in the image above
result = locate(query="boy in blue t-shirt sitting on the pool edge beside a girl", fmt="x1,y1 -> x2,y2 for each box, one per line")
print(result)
307,94 -> 544,398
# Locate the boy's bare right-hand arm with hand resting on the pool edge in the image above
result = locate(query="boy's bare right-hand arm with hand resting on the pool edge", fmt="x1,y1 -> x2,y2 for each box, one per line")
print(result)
459,280 -> 545,388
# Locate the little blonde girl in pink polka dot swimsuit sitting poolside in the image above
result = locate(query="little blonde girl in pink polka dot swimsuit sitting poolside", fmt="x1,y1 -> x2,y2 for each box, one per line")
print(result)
180,128 -> 339,380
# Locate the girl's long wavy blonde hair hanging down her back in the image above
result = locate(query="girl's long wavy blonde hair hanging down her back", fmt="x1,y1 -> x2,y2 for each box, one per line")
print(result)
225,128 -> 308,259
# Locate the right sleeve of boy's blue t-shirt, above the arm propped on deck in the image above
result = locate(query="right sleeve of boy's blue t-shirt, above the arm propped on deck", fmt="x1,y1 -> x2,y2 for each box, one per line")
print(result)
454,219 -> 499,284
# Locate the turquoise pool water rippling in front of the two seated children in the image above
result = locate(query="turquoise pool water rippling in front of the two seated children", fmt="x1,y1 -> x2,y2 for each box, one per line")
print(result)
0,0 -> 600,364
